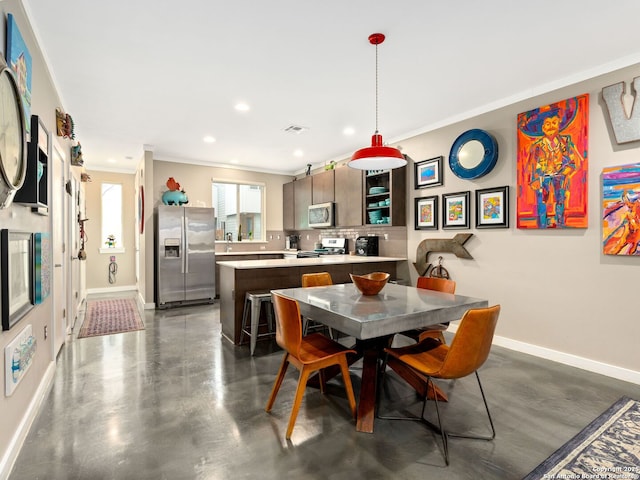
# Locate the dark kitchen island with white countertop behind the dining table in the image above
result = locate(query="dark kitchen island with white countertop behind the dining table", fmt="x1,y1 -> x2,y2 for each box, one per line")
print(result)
218,255 -> 407,345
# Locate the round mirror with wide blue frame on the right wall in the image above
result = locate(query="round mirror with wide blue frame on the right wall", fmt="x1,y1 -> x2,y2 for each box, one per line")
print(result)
449,128 -> 498,180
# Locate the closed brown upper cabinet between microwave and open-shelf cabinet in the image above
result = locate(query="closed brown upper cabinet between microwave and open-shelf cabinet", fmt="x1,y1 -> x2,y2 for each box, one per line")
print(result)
334,165 -> 363,227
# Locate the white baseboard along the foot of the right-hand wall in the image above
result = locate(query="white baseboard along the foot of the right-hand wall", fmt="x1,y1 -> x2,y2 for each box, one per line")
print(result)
448,323 -> 640,385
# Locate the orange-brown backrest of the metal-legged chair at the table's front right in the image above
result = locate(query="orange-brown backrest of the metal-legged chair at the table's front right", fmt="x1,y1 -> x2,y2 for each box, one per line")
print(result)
437,305 -> 500,378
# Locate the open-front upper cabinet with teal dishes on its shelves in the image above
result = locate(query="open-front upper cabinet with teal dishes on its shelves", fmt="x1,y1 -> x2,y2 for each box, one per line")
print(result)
363,166 -> 407,227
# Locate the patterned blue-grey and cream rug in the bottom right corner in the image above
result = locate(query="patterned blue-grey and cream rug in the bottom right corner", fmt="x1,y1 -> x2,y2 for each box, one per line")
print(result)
523,397 -> 640,480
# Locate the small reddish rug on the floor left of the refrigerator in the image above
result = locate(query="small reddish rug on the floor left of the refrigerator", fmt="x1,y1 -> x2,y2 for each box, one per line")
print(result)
78,298 -> 144,338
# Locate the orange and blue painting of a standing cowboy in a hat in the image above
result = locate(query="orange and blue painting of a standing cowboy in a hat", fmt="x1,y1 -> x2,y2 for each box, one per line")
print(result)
516,94 -> 589,229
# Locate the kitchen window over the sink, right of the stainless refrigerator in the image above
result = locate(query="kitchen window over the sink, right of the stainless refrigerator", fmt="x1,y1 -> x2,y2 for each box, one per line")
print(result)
211,182 -> 265,241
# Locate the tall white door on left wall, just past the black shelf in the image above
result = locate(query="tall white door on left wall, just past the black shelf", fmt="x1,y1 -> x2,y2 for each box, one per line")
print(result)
50,142 -> 71,358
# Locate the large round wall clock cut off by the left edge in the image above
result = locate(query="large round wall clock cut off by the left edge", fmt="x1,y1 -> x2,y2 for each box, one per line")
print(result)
0,54 -> 27,208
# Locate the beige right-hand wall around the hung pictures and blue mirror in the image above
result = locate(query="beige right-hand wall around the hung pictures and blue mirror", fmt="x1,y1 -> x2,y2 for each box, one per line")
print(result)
400,62 -> 640,382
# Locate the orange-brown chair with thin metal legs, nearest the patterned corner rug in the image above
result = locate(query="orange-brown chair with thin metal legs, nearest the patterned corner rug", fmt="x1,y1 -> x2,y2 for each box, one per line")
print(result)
378,305 -> 500,465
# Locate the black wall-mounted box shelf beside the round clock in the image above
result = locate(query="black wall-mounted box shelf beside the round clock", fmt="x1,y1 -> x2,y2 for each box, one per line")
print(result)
14,115 -> 49,215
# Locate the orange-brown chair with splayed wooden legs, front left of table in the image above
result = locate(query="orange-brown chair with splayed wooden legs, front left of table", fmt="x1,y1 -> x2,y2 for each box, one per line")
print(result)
265,293 -> 356,438
